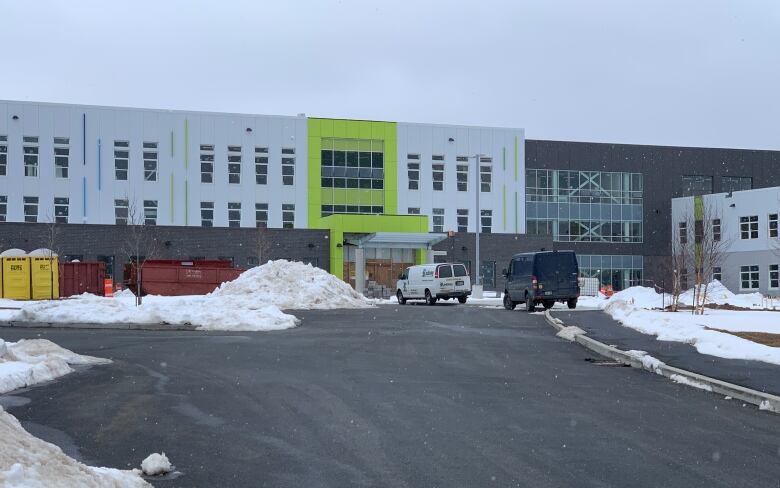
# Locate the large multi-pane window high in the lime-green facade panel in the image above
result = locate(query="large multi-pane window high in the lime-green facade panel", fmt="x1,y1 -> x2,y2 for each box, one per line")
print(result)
320,138 -> 385,193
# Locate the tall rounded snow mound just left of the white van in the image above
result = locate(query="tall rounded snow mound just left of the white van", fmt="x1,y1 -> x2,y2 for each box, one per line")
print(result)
209,259 -> 371,310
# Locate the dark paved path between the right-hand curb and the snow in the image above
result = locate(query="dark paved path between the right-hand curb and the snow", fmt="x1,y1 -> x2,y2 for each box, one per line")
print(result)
552,310 -> 780,395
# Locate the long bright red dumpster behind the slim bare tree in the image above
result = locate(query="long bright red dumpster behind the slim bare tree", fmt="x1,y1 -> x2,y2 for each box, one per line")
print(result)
124,259 -> 244,296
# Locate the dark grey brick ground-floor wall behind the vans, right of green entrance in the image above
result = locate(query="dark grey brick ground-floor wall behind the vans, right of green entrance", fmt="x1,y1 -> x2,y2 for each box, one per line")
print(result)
433,233 -> 553,290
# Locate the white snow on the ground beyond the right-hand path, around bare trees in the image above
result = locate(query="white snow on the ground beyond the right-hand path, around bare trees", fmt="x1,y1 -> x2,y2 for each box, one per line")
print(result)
599,281 -> 780,365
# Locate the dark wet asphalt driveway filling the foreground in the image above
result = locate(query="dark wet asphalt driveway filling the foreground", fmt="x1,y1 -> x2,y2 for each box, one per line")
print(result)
2,304 -> 780,488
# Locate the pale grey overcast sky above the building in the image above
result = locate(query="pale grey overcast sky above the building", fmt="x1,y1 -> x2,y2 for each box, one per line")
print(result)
0,0 -> 780,149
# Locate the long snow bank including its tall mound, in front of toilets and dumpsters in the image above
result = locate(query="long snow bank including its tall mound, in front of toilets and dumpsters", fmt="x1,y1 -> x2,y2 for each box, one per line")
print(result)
0,260 -> 373,331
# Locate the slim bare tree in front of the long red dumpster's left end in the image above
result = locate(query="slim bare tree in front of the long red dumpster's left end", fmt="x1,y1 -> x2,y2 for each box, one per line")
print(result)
122,196 -> 160,306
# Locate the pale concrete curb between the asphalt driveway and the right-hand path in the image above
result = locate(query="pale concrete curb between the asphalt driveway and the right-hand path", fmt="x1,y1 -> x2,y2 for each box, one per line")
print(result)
544,310 -> 780,413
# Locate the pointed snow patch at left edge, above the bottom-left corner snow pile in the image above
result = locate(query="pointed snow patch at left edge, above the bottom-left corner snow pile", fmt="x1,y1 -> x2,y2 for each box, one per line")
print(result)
0,339 -> 111,394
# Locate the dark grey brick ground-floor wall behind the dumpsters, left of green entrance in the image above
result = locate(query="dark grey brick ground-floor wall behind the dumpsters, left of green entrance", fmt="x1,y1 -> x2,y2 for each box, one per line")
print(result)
0,222 -> 330,278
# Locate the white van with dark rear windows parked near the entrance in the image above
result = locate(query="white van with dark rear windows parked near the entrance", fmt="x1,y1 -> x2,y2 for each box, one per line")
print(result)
395,263 -> 471,305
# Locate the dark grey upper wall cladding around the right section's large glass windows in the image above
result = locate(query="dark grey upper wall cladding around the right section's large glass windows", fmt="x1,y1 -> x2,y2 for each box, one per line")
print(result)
525,140 -> 780,282
